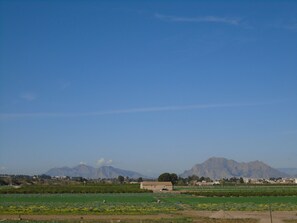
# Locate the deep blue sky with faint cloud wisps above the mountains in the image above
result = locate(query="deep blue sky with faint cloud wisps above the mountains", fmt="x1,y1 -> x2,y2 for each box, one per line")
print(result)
0,0 -> 297,176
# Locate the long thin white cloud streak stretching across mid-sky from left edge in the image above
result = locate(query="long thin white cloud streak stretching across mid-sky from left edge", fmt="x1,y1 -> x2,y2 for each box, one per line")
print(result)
0,102 -> 279,120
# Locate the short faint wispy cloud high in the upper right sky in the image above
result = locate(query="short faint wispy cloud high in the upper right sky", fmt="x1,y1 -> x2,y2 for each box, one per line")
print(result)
155,14 -> 241,25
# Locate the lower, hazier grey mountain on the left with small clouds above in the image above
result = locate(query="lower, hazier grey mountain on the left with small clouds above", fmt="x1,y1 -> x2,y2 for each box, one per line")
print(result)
45,164 -> 145,179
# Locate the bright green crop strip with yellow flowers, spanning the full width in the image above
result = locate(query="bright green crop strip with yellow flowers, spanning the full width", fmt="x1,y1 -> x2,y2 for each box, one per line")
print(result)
0,193 -> 297,215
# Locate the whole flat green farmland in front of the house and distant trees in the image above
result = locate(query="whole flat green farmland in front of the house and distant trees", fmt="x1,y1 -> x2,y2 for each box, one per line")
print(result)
0,185 -> 297,223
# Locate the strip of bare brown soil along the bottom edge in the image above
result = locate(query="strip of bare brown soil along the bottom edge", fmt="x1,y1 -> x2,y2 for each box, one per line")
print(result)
0,210 -> 297,223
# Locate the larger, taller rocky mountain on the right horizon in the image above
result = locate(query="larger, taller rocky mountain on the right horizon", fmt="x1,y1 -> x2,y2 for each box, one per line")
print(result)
181,157 -> 288,179
